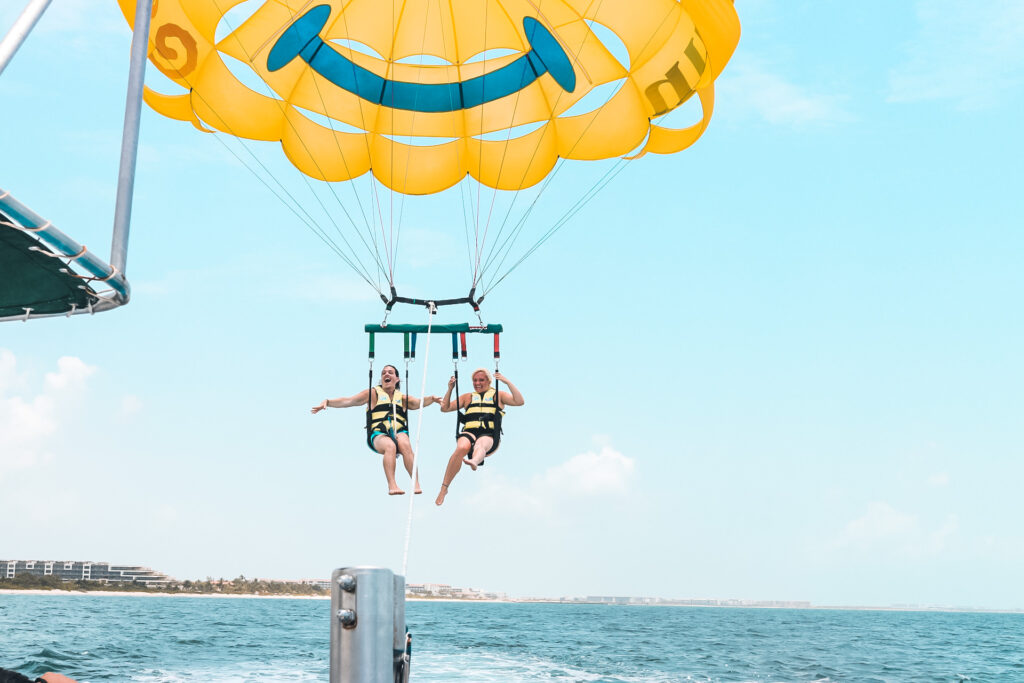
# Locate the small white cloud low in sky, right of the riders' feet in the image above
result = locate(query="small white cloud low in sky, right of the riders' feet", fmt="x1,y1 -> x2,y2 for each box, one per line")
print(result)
470,443 -> 636,514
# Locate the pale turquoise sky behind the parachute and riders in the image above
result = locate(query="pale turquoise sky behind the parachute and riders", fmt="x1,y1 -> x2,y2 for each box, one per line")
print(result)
0,0 -> 1024,608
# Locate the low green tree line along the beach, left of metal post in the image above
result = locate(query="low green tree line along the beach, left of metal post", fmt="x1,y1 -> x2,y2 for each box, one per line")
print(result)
0,574 -> 330,596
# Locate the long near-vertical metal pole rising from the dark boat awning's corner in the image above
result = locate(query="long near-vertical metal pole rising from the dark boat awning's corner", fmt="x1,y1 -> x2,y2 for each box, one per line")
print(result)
111,0 -> 153,280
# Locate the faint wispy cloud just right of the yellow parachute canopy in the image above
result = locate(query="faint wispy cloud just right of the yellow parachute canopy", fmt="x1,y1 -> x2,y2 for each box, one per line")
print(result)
718,61 -> 852,127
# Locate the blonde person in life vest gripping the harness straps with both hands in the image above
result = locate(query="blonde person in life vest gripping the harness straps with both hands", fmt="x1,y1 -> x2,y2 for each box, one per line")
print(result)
434,368 -> 526,505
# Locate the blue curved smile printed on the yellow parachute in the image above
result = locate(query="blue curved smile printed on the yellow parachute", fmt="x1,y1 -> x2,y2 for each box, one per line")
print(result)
266,5 -> 575,113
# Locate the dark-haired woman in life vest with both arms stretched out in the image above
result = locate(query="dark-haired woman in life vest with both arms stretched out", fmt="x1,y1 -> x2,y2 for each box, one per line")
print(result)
310,366 -> 440,496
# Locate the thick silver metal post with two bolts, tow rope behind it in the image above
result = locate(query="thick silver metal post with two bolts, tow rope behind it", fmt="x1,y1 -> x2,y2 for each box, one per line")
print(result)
330,567 -> 409,683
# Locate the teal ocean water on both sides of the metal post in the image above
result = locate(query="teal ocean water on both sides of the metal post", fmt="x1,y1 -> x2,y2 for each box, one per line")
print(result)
0,594 -> 1024,683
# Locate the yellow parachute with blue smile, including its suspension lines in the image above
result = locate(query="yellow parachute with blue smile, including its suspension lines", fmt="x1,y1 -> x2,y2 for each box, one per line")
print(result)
119,0 -> 739,307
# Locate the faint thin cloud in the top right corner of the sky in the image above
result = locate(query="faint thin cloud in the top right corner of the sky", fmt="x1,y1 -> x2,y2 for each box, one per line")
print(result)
889,0 -> 1024,110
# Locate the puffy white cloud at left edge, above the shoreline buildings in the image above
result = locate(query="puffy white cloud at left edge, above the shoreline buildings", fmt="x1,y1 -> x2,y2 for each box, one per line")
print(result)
0,349 -> 96,475
